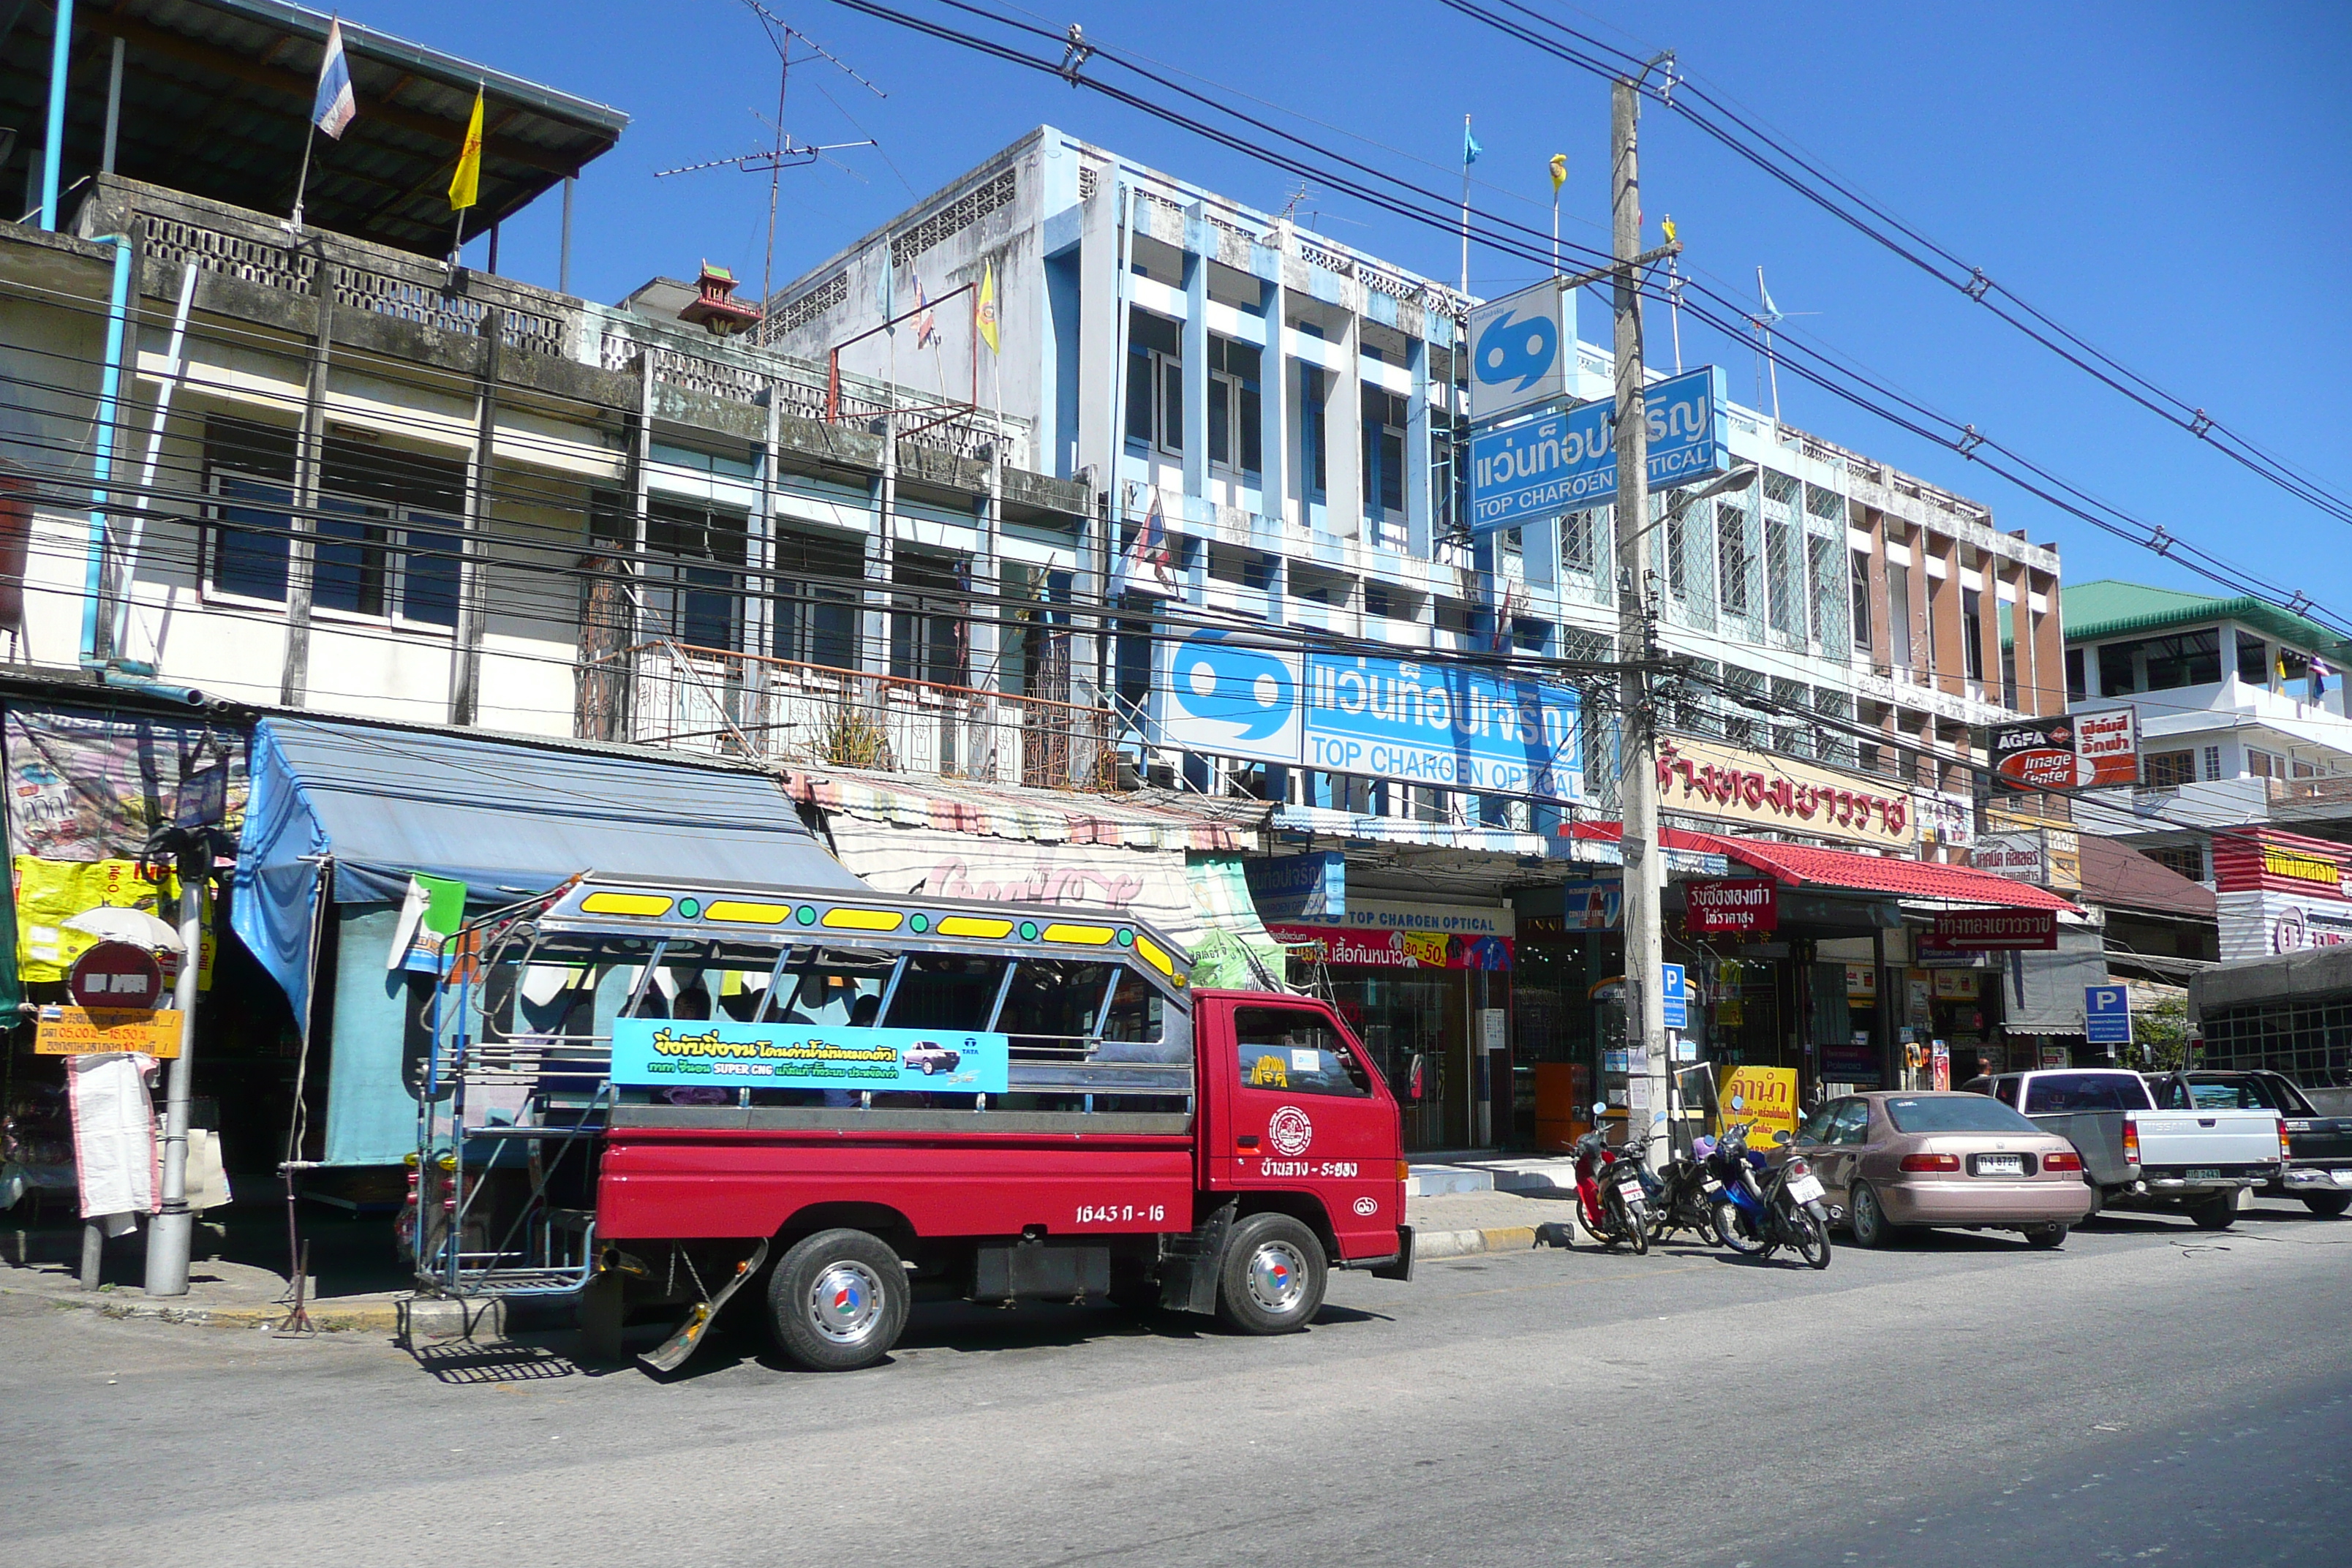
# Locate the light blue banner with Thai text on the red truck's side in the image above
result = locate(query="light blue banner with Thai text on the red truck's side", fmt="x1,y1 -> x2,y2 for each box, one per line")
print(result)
611,1018 -> 1011,1093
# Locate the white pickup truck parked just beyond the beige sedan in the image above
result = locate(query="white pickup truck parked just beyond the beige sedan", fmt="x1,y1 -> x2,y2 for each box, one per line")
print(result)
1967,1067 -> 2286,1229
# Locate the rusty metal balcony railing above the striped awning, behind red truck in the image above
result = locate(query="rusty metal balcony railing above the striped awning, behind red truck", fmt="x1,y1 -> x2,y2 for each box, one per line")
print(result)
606,642 -> 1117,790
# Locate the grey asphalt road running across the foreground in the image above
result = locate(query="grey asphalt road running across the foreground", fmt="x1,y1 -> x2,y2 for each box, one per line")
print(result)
0,1206 -> 2352,1568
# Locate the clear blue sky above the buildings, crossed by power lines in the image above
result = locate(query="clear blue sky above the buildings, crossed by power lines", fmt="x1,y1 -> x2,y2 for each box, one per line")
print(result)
362,0 -> 2352,618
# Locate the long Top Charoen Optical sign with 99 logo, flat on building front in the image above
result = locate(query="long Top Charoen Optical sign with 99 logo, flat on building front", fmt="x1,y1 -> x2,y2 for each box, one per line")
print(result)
1159,630 -> 1586,802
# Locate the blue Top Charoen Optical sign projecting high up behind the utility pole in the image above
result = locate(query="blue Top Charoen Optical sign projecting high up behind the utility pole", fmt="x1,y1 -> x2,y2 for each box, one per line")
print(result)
1470,364 -> 1731,534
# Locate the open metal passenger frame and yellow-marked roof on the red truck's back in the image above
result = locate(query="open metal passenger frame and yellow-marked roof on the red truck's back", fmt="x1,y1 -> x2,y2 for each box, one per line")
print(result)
410,875 -> 1197,1295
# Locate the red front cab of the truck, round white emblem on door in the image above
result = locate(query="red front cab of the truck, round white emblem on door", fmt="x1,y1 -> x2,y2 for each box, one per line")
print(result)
1205,1001 -> 1404,1258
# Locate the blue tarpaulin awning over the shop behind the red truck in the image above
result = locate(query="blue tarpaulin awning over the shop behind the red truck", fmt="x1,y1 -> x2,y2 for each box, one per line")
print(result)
230,717 -> 865,1044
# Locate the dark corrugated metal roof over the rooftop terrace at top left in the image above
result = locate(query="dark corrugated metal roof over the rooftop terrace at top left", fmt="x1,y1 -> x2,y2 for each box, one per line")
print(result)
0,0 -> 628,256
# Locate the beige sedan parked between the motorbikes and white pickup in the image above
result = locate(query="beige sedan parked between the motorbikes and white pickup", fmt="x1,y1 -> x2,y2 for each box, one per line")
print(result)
1790,1090 -> 2098,1246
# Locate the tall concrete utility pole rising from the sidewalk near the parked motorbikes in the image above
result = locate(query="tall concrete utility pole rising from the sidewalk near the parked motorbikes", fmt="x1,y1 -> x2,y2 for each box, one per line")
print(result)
1609,78 -> 1665,1138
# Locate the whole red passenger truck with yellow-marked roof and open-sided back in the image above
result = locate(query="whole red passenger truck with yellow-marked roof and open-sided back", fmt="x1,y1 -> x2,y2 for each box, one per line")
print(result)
418,879 -> 1414,1371
